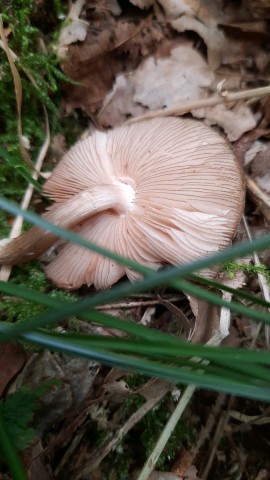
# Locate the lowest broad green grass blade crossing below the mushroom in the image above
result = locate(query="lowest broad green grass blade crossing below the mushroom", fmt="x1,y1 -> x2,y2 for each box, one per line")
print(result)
0,318 -> 270,400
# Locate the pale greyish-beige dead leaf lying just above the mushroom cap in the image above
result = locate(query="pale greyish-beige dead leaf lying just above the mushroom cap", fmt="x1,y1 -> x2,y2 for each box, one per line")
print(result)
99,45 -> 215,126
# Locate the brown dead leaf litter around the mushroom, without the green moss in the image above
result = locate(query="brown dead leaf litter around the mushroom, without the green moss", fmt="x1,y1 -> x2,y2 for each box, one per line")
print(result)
0,0 -> 270,480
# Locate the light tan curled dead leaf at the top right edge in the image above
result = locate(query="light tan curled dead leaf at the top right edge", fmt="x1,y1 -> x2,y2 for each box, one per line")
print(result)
132,0 -> 269,73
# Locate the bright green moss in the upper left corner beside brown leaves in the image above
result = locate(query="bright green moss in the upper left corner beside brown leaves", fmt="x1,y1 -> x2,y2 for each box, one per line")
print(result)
0,0 -> 67,217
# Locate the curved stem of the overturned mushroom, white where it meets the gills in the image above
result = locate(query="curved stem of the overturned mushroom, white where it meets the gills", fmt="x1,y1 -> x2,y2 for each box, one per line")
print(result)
0,183 -> 133,265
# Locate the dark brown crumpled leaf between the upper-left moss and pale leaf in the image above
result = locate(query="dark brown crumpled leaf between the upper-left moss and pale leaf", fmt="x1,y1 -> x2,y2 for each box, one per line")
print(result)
62,0 -> 166,116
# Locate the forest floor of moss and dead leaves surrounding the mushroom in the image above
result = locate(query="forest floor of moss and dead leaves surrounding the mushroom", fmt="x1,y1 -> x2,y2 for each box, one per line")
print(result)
0,0 -> 270,480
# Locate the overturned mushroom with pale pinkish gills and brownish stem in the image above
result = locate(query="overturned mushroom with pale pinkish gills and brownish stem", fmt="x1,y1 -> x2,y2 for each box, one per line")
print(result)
0,117 -> 245,289
